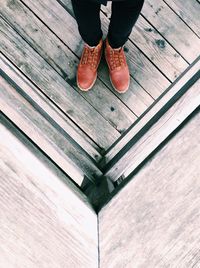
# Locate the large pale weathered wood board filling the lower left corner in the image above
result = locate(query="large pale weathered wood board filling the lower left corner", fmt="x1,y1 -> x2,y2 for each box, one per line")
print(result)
0,119 -> 98,268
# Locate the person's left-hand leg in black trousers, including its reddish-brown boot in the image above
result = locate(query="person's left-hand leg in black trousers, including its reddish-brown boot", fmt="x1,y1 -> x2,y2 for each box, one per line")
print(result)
72,0 -> 103,91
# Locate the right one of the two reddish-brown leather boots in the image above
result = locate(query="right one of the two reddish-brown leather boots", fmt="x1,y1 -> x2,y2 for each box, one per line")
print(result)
105,39 -> 130,93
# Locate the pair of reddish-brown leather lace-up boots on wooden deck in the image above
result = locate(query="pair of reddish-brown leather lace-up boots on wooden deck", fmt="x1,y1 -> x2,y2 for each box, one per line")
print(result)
77,39 -> 130,93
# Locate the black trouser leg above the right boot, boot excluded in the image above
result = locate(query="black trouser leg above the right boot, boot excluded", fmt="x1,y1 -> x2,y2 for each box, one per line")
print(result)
108,0 -> 144,48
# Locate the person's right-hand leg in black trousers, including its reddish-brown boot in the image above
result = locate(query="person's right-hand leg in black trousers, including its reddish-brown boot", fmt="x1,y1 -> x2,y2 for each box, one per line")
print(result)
105,0 -> 144,93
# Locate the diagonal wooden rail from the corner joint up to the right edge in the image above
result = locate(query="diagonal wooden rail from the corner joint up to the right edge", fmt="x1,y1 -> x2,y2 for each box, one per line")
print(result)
102,60 -> 200,181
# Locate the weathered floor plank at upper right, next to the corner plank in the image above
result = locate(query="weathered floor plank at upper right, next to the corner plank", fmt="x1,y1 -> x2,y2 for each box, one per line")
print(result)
142,0 -> 200,63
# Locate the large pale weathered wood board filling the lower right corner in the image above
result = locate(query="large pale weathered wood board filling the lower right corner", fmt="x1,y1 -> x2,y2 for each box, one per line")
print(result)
99,109 -> 200,268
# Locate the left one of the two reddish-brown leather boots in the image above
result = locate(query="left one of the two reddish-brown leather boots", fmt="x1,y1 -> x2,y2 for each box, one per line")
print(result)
77,40 -> 103,91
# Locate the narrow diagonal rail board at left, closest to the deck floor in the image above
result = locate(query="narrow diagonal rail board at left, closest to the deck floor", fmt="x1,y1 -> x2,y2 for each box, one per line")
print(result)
0,54 -> 101,161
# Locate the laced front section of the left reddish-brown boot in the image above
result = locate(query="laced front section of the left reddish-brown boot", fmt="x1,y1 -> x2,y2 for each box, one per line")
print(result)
81,45 -> 98,69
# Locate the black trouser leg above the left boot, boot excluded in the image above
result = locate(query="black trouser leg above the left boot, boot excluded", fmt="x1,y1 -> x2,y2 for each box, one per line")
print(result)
71,0 -> 103,46
